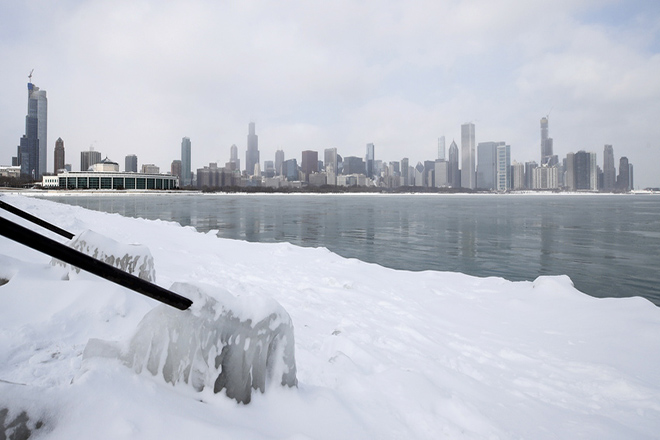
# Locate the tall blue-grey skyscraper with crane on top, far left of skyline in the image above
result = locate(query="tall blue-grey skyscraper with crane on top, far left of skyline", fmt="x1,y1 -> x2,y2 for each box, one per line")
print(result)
18,78 -> 48,179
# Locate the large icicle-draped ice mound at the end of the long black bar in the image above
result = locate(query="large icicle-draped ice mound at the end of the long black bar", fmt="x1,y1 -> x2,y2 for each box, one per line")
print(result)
83,283 -> 298,403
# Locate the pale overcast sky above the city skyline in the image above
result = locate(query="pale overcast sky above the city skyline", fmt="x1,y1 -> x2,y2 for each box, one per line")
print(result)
0,0 -> 660,187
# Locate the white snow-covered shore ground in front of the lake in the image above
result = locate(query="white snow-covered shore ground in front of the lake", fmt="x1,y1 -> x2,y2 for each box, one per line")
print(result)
0,195 -> 660,439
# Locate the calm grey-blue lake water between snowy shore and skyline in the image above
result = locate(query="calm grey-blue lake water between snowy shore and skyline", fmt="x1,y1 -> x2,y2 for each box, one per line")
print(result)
40,194 -> 660,305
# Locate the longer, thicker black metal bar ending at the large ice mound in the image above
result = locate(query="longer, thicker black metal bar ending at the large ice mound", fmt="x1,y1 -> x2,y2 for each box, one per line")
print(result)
0,217 -> 192,310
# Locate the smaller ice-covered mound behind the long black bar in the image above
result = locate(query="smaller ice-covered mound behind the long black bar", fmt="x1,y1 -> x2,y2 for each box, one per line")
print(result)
51,229 -> 156,283
